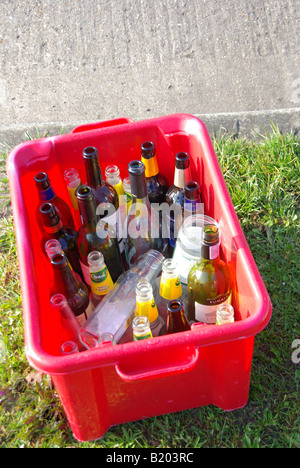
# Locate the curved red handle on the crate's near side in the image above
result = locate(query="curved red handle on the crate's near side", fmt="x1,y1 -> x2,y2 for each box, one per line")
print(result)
115,348 -> 199,382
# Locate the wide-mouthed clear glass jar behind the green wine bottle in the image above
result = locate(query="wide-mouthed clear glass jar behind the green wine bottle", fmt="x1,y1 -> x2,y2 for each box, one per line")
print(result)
173,214 -> 219,294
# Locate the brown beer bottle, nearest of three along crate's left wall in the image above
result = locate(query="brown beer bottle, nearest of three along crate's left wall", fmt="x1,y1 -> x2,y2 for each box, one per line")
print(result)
51,254 -> 92,326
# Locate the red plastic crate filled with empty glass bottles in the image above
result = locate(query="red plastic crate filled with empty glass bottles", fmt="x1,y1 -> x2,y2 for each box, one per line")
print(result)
7,114 -> 272,441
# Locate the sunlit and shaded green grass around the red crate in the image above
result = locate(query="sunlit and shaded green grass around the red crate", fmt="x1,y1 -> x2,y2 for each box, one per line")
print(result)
0,127 -> 300,448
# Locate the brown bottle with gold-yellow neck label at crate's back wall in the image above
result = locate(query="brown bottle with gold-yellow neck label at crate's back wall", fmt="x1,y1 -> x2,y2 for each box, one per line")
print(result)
141,141 -> 169,204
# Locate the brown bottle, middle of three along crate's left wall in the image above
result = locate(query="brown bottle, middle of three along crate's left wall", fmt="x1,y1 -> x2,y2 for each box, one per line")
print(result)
40,202 -> 83,279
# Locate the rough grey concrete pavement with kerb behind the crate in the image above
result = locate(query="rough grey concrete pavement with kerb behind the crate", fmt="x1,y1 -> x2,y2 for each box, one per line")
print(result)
0,0 -> 300,146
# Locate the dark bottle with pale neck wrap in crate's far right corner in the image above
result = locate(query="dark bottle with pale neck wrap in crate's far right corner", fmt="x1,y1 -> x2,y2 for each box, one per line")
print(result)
166,152 -> 191,251
